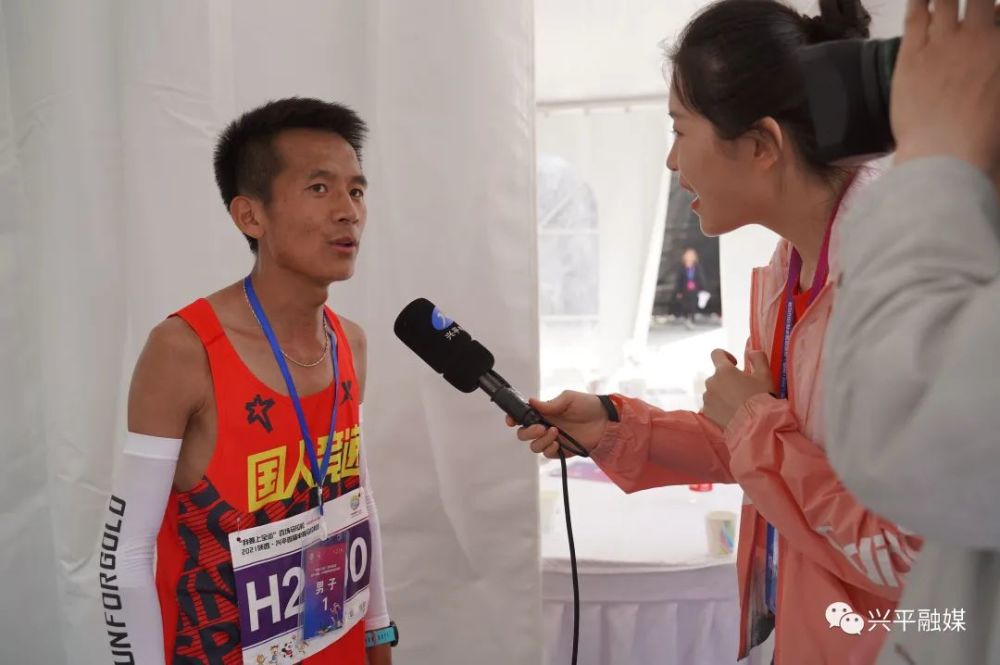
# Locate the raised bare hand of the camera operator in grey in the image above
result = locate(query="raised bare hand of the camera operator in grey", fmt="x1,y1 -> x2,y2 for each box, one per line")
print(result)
891,0 -> 1000,185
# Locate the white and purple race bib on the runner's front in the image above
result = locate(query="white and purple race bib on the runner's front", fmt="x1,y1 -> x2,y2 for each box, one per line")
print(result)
229,487 -> 371,665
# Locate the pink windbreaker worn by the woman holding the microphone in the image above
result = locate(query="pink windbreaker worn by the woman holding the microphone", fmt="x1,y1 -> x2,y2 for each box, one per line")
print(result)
592,185 -> 921,665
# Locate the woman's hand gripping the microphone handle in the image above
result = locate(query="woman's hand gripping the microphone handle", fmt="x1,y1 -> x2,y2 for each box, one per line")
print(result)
507,390 -> 608,459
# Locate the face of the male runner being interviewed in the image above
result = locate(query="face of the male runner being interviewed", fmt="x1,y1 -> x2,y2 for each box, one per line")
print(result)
259,129 -> 367,282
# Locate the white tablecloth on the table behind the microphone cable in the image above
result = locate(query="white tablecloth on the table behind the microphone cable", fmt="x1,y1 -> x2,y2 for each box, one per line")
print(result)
542,460 -> 770,665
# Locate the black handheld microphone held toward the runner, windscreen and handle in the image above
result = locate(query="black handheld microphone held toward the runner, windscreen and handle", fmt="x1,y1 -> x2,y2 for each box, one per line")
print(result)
393,298 -> 588,457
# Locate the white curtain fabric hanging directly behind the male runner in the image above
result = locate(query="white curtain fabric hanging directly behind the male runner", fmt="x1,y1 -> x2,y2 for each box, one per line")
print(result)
0,0 -> 542,665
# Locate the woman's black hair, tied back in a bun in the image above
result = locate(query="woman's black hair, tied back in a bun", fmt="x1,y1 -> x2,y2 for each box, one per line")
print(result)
668,0 -> 871,182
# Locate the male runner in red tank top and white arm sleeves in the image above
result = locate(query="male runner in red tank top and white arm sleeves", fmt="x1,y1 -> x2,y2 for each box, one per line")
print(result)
100,98 -> 395,665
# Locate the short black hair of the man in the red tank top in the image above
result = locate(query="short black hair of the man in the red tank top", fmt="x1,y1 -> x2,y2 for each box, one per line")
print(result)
214,97 -> 368,253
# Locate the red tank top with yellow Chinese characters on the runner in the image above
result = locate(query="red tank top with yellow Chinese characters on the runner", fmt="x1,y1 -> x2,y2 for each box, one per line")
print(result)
156,299 -> 365,665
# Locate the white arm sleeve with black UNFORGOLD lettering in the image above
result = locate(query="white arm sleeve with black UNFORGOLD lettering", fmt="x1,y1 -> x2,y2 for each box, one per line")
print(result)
98,432 -> 181,665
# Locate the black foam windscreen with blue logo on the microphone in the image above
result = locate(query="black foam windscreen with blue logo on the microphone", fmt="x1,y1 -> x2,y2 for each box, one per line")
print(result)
393,298 -> 493,393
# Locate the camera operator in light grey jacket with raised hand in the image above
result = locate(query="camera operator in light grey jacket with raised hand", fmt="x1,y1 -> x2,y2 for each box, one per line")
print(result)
825,0 -> 1000,665
